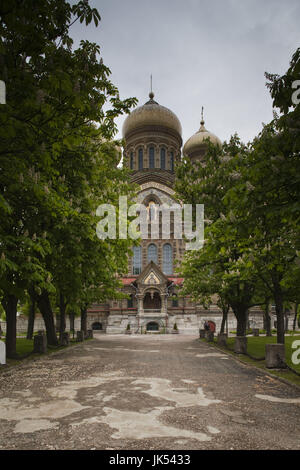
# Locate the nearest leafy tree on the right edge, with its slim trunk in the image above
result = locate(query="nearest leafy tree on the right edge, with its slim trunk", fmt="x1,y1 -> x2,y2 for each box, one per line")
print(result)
226,104 -> 300,343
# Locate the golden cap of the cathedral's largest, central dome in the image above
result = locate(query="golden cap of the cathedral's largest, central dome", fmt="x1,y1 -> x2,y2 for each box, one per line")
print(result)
123,93 -> 182,138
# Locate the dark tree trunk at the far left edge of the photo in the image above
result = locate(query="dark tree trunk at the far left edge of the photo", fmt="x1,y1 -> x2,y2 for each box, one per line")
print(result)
2,294 -> 18,359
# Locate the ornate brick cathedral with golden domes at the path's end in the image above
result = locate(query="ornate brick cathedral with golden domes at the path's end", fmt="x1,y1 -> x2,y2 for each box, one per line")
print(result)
88,92 -> 264,334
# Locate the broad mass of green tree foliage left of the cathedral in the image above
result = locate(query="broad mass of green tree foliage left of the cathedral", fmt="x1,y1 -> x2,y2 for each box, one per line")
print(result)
0,0 -> 136,352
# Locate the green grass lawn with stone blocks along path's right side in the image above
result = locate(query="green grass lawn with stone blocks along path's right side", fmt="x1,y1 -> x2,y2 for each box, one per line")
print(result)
210,334 -> 300,386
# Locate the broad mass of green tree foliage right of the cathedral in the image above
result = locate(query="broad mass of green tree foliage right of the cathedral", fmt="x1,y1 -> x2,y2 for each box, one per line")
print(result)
176,49 -> 300,342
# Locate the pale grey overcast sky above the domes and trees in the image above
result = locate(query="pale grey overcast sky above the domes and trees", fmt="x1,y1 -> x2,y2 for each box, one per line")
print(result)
71,0 -> 300,142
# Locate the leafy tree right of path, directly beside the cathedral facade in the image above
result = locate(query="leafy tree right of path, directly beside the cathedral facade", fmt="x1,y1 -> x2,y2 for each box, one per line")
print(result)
176,136 -> 260,336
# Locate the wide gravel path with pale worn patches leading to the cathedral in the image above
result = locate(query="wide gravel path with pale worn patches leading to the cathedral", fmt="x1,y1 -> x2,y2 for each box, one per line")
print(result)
0,334 -> 300,450
